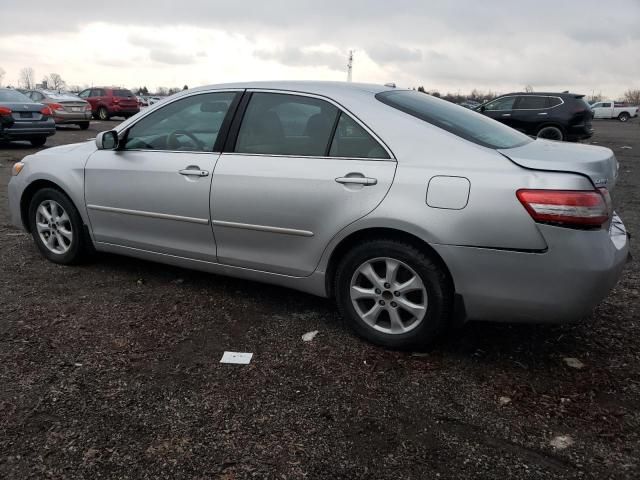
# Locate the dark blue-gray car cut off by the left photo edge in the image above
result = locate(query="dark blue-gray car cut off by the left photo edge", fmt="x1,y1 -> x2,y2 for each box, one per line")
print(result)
0,88 -> 56,147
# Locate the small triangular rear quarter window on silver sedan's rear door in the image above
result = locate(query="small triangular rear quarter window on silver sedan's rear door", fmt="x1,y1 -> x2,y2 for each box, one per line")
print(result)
329,113 -> 389,158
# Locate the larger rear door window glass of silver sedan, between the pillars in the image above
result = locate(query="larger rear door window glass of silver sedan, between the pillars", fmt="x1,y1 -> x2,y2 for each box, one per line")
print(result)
235,93 -> 338,156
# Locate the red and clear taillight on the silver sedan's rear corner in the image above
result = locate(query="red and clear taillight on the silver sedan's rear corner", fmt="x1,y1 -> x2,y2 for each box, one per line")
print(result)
516,189 -> 609,227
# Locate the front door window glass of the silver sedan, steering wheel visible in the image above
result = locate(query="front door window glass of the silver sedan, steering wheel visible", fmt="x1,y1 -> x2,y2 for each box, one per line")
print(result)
124,92 -> 237,152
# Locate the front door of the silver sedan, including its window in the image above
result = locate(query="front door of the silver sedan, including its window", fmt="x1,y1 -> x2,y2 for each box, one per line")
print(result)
85,92 -> 240,262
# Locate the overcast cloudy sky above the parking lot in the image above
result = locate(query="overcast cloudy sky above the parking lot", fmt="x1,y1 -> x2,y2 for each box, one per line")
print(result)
0,0 -> 640,97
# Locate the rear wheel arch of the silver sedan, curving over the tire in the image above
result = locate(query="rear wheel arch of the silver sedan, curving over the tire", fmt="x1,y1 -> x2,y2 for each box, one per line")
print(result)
325,227 -> 455,298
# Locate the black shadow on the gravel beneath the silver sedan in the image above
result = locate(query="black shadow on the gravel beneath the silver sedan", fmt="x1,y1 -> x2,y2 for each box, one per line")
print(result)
79,249 -> 592,362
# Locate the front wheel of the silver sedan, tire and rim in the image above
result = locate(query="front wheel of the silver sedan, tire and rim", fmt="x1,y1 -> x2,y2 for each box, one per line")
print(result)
29,188 -> 92,265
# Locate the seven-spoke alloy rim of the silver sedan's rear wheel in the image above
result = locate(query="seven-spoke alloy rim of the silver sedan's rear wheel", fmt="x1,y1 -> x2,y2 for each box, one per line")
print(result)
349,257 -> 428,335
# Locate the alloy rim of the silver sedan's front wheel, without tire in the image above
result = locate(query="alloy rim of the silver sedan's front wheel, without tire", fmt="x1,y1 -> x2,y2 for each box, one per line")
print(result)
36,200 -> 73,255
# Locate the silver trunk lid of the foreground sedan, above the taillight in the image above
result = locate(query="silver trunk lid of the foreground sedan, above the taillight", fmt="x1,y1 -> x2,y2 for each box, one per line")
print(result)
498,140 -> 618,191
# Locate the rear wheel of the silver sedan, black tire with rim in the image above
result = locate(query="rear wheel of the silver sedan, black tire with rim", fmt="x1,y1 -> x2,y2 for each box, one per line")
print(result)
334,239 -> 453,349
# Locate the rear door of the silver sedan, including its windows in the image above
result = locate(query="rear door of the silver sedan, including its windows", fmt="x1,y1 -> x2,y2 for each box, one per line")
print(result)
211,92 -> 396,276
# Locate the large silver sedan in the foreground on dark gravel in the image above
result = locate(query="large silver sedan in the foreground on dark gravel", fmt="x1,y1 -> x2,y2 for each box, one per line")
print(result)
9,82 -> 628,348
